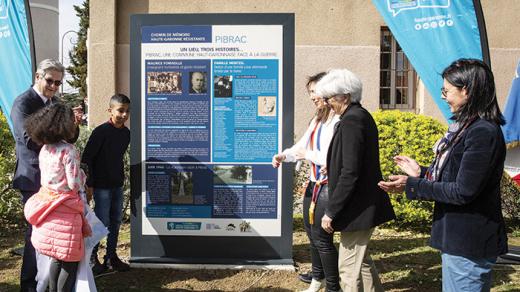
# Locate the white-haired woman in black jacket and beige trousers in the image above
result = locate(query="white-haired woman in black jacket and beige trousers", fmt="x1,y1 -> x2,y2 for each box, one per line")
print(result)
316,69 -> 395,291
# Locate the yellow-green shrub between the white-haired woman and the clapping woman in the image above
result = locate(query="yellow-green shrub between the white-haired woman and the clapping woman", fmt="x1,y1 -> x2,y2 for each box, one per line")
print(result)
373,111 -> 447,231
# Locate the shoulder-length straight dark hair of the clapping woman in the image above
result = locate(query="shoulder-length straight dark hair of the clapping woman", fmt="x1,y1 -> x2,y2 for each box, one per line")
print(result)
442,59 -> 505,125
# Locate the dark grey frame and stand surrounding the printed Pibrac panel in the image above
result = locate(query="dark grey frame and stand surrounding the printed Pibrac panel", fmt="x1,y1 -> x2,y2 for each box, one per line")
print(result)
130,14 -> 294,266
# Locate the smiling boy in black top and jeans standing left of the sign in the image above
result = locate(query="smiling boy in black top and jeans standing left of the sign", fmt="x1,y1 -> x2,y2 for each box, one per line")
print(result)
81,94 -> 130,274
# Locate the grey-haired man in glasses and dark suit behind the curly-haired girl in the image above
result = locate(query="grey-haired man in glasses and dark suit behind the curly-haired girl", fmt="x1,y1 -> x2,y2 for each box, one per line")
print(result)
11,59 -> 83,291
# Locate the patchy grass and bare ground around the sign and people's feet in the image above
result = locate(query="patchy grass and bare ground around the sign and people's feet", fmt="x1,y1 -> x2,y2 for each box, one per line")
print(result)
0,218 -> 520,292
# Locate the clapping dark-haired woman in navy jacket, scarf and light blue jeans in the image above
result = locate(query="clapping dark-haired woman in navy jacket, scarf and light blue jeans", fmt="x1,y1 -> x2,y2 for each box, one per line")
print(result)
379,59 -> 507,291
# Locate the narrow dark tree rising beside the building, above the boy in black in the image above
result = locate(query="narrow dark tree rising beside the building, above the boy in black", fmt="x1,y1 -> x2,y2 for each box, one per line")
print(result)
67,0 -> 89,100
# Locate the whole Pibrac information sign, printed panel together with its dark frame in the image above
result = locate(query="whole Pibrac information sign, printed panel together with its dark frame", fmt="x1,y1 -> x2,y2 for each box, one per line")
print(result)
130,13 -> 294,267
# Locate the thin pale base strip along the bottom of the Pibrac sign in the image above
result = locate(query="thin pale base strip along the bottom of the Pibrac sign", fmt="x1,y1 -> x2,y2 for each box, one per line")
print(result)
130,263 -> 296,272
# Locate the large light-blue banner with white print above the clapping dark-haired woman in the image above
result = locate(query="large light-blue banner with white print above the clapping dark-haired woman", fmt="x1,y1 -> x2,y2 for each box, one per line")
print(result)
372,0 -> 489,119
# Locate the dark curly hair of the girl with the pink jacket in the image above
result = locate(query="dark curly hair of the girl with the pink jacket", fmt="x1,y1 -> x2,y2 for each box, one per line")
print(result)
25,103 -> 76,144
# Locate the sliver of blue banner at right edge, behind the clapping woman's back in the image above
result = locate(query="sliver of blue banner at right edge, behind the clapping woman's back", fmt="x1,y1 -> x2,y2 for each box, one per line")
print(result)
502,62 -> 520,148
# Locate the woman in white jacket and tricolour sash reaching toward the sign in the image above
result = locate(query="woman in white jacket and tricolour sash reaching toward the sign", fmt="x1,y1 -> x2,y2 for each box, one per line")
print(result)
273,72 -> 340,292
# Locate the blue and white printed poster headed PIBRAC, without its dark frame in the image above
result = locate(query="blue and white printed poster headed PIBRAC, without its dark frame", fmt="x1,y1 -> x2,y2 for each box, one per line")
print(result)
141,25 -> 283,236
